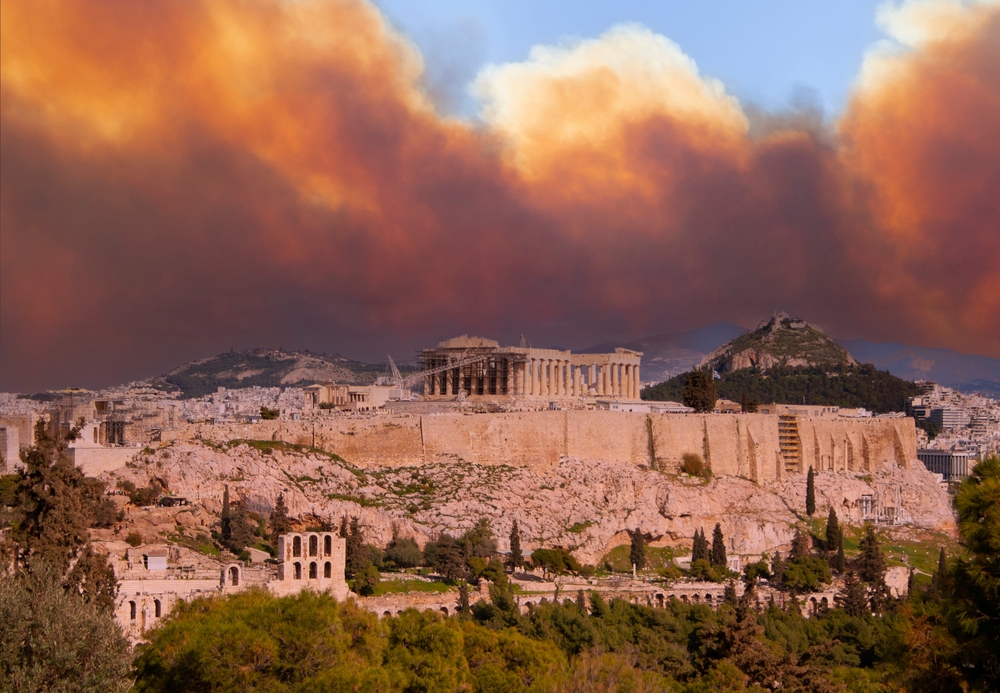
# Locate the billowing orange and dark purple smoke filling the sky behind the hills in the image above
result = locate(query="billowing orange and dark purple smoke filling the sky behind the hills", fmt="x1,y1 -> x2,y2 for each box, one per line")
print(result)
0,0 -> 1000,391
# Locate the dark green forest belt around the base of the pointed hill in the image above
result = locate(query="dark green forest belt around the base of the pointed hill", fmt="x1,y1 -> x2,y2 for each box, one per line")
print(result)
642,364 -> 919,414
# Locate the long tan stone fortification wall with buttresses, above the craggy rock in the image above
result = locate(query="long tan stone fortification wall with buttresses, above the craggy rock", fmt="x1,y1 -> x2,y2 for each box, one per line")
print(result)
162,410 -> 917,483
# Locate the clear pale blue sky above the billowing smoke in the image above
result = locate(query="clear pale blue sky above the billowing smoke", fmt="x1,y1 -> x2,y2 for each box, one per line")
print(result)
377,0 -> 881,118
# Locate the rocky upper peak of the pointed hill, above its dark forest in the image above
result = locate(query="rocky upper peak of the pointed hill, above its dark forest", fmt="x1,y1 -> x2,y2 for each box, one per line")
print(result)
699,313 -> 857,371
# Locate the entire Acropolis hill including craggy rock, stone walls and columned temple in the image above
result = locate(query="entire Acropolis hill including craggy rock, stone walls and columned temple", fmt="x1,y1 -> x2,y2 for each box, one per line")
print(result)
5,336 -> 954,562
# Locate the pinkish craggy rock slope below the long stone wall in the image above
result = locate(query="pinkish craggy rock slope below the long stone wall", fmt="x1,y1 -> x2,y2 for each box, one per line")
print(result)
104,442 -> 954,563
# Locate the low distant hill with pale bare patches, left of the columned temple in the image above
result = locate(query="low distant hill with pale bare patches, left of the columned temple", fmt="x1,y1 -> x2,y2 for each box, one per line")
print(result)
149,349 -> 411,397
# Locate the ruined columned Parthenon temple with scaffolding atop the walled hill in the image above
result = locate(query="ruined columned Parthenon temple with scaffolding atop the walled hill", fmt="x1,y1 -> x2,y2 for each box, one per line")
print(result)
421,335 -> 642,400
